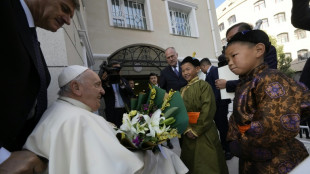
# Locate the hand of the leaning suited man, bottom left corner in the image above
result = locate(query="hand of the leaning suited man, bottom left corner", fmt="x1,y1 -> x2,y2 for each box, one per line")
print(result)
0,150 -> 47,174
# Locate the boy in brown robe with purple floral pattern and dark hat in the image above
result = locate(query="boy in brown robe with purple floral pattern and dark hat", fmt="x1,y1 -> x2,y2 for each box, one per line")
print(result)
225,30 -> 310,174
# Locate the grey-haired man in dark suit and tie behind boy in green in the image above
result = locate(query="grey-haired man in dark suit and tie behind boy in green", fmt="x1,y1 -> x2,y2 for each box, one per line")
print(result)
159,47 -> 187,92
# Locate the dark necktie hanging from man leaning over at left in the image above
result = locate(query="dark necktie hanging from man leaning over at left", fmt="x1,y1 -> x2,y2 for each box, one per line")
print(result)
30,27 -> 47,119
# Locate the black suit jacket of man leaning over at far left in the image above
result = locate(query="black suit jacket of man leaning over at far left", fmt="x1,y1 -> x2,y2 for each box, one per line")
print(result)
0,0 -> 50,151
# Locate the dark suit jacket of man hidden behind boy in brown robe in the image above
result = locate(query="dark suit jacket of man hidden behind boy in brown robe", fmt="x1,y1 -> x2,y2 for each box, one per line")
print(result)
226,45 -> 278,92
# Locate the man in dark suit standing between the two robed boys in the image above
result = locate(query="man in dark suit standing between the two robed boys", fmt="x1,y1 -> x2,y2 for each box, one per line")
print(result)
200,58 -> 233,160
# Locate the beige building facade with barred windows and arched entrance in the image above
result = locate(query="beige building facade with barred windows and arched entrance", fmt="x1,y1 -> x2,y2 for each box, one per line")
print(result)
37,0 -> 222,104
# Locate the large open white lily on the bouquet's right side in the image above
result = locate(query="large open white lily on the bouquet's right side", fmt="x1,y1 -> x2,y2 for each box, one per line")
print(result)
143,109 -> 165,137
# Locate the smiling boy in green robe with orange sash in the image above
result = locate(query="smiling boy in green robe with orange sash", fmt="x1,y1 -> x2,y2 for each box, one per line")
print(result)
181,57 -> 228,174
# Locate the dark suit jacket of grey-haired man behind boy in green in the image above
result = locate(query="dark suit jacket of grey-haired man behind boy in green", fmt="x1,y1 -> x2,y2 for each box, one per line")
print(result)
159,62 -> 187,92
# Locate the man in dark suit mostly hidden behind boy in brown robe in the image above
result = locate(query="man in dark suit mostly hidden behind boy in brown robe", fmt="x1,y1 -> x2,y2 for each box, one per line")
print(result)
215,22 -> 278,92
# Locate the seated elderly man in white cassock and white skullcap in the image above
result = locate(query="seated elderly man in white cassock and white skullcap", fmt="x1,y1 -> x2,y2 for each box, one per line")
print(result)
24,65 -> 188,174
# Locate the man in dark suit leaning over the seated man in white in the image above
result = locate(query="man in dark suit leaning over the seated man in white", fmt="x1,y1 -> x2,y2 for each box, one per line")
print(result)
0,0 -> 78,173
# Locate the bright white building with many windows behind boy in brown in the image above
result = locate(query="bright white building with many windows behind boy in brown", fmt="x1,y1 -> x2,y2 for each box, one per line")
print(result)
216,0 -> 310,72
